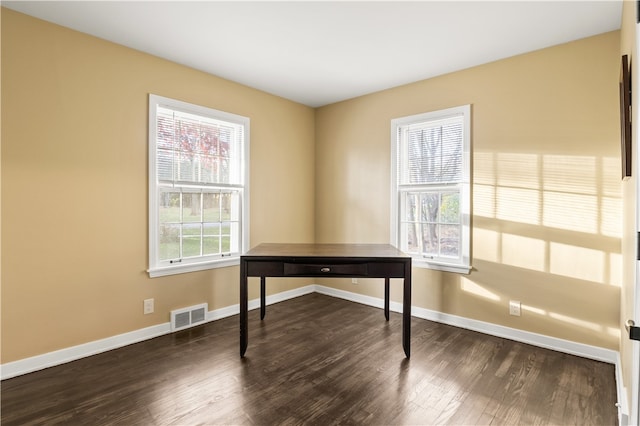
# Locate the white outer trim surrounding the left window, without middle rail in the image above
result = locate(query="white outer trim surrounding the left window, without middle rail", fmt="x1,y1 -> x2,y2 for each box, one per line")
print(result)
147,94 -> 250,278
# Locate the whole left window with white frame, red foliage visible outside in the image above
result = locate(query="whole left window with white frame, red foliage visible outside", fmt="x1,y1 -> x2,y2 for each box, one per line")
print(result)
148,95 -> 249,277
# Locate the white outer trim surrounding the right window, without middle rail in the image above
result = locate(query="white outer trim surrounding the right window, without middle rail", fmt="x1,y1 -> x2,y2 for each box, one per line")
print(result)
390,105 -> 472,274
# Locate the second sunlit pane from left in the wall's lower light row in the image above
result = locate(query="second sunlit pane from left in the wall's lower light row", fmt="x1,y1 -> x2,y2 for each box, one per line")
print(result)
502,234 -> 547,271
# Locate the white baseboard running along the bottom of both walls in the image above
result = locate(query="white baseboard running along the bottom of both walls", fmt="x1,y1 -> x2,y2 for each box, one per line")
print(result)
0,285 -> 619,386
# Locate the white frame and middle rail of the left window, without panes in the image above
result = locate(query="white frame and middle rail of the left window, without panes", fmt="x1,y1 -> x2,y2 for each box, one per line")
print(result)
147,94 -> 250,278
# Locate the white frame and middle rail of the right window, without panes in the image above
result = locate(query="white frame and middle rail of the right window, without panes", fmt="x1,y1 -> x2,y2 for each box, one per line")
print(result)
390,105 -> 471,274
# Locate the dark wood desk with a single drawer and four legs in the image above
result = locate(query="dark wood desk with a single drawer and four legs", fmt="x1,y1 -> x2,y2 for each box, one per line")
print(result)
240,244 -> 411,358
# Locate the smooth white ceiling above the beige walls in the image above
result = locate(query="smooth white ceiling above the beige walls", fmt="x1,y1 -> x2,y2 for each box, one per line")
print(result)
2,0 -> 622,107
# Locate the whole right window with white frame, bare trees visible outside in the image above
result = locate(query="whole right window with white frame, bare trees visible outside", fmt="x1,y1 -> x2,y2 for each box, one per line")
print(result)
391,105 -> 471,273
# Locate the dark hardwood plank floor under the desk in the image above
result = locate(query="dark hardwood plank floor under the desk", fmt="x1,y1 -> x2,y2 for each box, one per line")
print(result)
1,294 -> 617,426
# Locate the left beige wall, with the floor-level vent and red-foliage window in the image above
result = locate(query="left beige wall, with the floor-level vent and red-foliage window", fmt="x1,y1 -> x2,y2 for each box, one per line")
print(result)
2,9 -> 314,363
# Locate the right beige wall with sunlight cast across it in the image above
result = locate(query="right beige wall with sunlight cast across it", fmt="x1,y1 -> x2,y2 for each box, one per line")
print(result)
316,32 -> 621,349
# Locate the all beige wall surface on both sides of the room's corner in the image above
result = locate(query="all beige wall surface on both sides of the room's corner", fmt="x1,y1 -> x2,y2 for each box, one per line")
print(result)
2,9 -> 622,363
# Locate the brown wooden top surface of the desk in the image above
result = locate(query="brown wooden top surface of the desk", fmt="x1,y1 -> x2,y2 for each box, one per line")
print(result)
243,243 -> 410,258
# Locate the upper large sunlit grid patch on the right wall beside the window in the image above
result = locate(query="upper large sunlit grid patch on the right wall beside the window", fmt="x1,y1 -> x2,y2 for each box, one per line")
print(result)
473,152 -> 622,238
